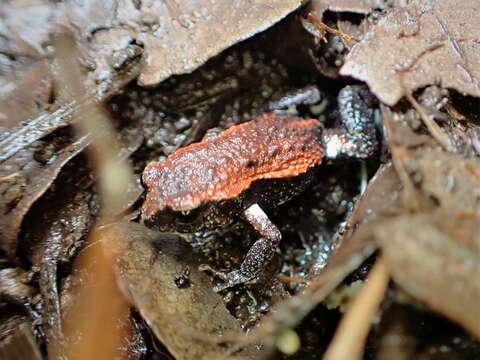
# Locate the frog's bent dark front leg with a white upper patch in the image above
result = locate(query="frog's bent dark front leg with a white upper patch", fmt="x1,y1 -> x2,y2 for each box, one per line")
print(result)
203,204 -> 282,292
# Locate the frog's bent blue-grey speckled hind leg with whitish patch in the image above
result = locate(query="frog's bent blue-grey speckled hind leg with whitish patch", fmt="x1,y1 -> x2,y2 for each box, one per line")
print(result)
322,85 -> 378,159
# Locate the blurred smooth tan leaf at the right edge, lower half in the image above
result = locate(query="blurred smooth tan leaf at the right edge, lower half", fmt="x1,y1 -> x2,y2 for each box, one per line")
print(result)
375,209 -> 480,338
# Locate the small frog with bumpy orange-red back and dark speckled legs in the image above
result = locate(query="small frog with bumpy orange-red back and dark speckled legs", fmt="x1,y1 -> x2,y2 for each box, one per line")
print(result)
142,85 -> 378,291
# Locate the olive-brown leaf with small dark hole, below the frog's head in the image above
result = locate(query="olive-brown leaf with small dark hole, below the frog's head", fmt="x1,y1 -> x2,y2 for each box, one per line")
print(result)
104,224 -> 258,359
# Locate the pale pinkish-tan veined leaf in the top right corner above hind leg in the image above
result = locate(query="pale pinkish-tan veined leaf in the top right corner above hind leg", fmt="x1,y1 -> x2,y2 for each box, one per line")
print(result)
340,0 -> 480,105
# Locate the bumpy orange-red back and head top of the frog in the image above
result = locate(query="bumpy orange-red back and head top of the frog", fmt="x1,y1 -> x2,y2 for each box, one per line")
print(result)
143,113 -> 323,217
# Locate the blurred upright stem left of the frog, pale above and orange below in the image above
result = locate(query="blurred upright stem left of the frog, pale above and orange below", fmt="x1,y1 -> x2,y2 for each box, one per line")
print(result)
52,36 -> 133,360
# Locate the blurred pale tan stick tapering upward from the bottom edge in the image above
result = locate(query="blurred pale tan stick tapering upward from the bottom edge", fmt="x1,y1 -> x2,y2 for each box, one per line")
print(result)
323,257 -> 390,360
